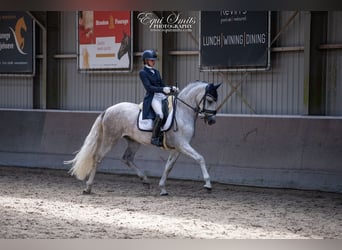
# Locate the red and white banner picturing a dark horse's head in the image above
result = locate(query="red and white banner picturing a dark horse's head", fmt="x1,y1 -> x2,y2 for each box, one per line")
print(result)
78,11 -> 133,71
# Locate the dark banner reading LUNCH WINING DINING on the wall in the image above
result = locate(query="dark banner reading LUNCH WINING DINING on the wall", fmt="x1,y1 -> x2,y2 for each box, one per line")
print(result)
200,11 -> 270,70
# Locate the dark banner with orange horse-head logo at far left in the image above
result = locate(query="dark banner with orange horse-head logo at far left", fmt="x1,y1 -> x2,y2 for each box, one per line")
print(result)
0,11 -> 34,75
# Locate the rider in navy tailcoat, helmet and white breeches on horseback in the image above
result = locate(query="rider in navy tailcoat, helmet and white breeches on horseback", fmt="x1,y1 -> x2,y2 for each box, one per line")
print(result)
139,50 -> 178,147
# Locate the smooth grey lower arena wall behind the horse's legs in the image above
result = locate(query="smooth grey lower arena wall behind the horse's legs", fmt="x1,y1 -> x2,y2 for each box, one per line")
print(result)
0,110 -> 342,192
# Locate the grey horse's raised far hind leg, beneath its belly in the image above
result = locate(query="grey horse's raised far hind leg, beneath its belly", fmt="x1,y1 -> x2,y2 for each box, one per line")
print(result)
122,137 -> 150,184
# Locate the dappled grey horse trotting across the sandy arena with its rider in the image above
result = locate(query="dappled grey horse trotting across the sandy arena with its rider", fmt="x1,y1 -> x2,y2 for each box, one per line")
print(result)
65,81 -> 220,195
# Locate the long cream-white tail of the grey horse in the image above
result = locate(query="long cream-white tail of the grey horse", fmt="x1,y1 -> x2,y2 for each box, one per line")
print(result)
64,113 -> 104,180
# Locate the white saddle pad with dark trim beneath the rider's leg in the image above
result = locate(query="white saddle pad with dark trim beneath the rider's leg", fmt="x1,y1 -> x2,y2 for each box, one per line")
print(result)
137,96 -> 175,132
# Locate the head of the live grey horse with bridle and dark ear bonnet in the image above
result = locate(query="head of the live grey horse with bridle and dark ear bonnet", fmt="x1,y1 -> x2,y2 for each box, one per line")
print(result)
199,83 -> 221,125
